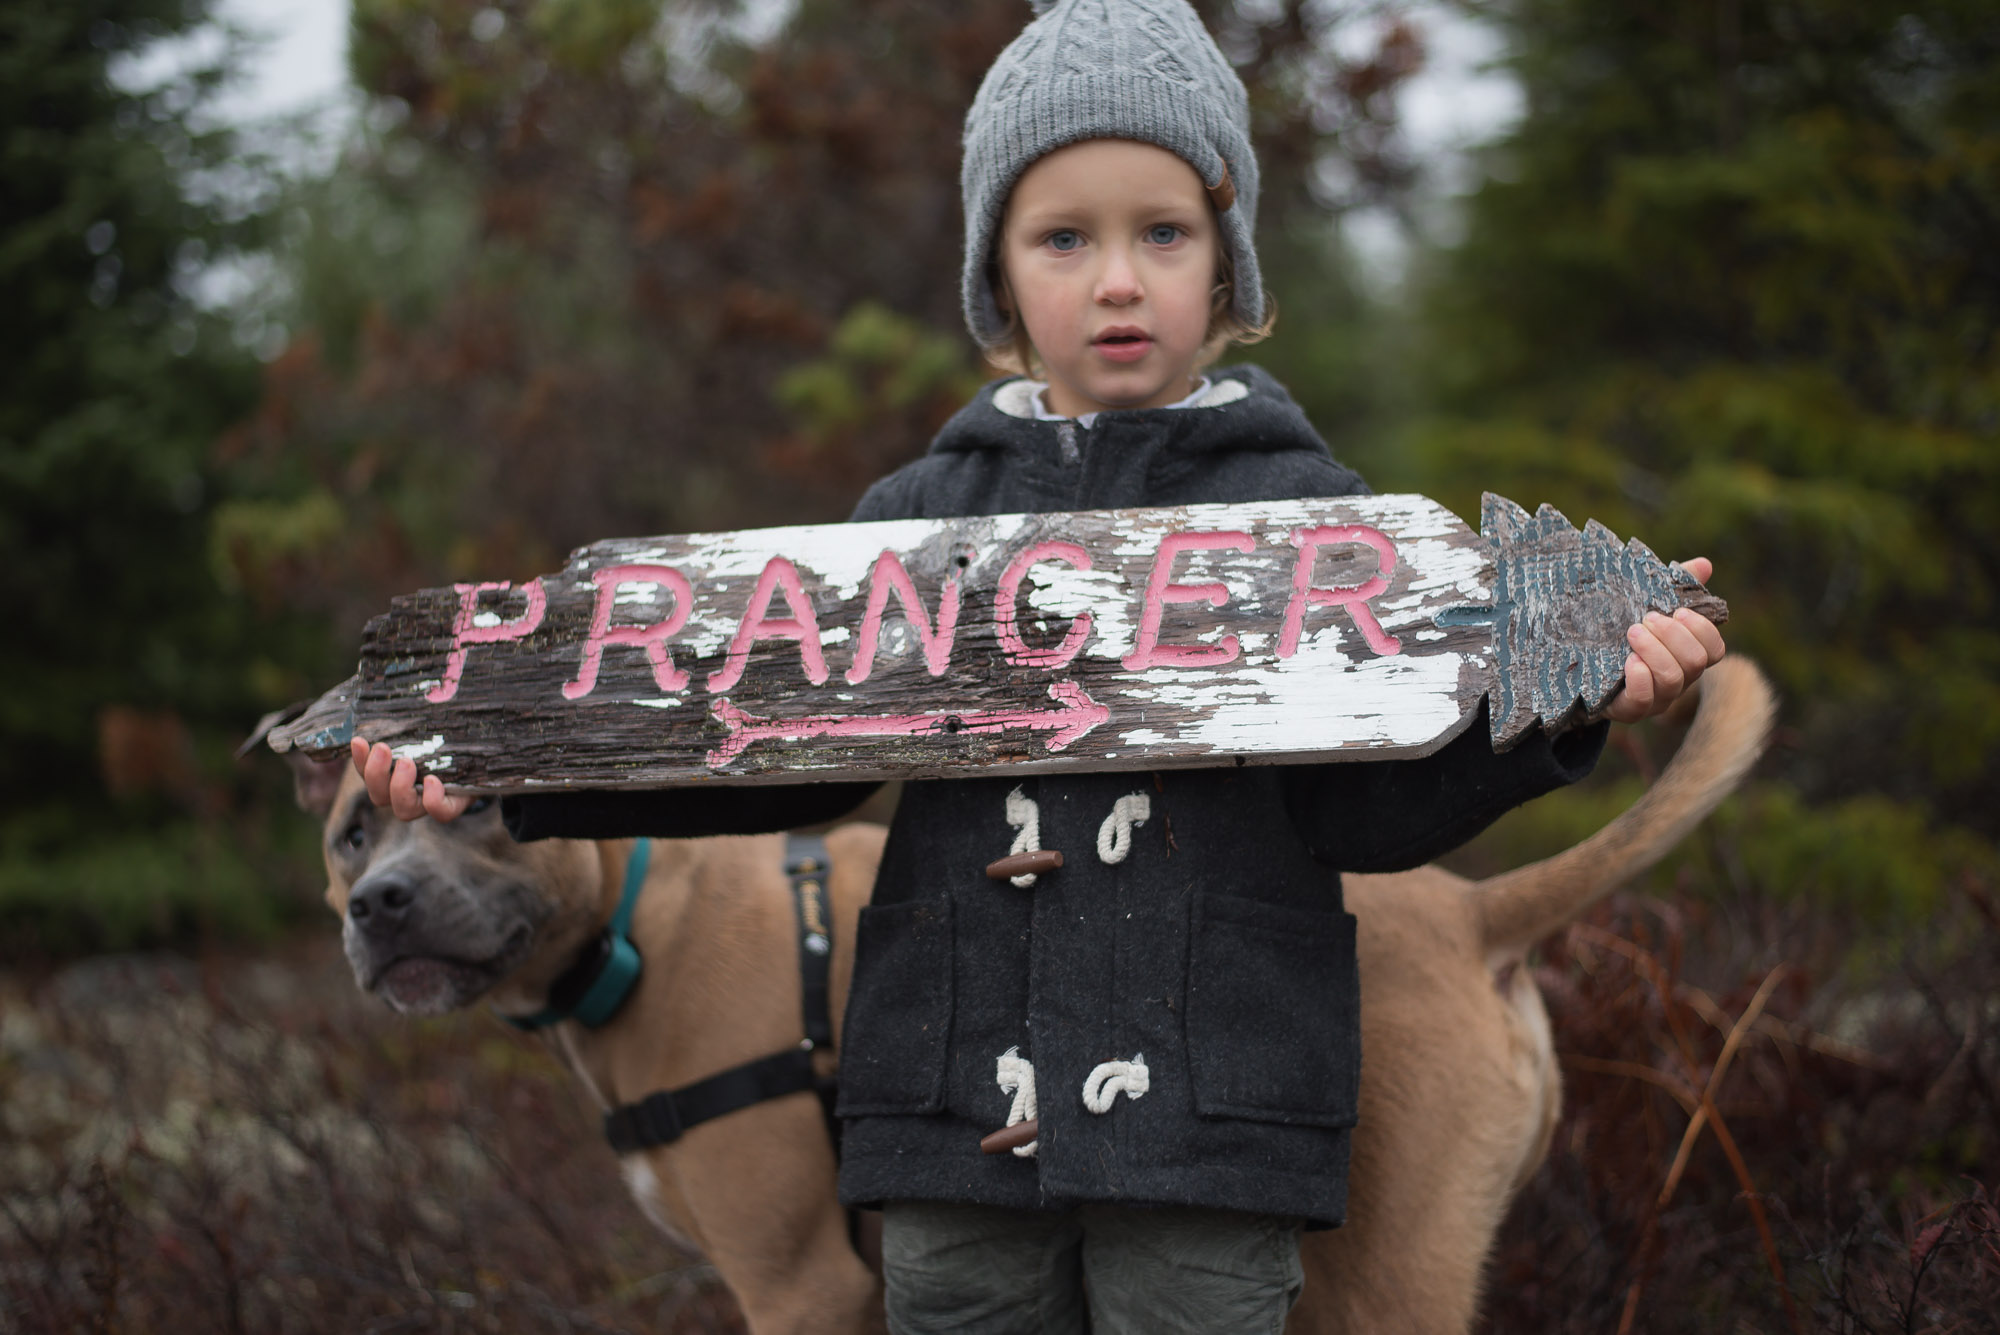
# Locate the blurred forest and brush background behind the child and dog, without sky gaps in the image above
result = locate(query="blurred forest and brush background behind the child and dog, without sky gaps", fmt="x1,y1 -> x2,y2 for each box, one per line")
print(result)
0,0 -> 2000,1331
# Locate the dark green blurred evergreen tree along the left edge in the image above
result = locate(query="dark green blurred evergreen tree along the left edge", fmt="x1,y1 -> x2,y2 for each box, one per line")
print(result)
0,0 -> 316,953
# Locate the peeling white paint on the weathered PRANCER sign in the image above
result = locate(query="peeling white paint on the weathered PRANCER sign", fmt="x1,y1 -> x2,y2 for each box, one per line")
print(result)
348,496 -> 1528,773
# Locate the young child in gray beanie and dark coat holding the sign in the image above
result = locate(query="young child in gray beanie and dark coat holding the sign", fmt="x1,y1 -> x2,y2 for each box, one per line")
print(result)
356,0 -> 1722,1333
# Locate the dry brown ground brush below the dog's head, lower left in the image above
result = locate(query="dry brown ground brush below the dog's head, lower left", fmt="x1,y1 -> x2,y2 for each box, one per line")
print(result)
0,935 -> 742,1335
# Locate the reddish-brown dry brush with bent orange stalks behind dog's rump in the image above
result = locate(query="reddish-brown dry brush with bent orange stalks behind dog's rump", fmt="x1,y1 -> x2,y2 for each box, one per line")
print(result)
1484,885 -> 2000,1335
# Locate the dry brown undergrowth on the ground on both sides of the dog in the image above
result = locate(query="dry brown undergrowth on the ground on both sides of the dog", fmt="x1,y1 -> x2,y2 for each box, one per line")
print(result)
0,871 -> 2000,1335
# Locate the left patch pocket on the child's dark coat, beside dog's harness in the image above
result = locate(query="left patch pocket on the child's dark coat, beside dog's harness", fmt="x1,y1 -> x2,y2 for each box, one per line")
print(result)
836,899 -> 952,1117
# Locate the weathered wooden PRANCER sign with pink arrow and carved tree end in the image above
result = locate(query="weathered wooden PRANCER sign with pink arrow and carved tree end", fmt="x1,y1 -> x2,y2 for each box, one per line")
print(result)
270,496 -> 1726,791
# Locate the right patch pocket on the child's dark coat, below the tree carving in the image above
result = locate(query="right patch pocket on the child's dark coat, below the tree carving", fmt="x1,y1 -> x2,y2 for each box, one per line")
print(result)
1186,893 -> 1360,1127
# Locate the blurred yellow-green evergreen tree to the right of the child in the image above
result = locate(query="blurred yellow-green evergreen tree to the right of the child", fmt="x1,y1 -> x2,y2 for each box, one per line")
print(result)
1378,0 -> 2000,913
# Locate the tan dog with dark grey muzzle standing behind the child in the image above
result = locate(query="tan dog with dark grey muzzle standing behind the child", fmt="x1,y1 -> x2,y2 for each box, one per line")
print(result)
286,660 -> 1772,1335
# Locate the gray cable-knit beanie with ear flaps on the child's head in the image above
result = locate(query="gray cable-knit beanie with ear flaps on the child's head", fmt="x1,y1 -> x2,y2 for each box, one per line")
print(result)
958,0 -> 1264,348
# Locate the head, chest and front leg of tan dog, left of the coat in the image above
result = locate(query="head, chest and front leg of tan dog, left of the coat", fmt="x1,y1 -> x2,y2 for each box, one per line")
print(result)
298,761 -> 884,1335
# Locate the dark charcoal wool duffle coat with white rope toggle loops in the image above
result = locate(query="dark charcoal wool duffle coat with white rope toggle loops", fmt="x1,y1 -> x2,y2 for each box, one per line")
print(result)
504,368 -> 1604,1223
